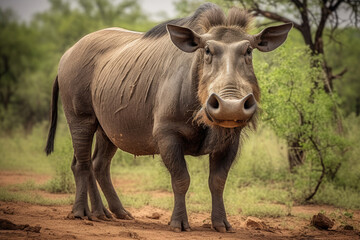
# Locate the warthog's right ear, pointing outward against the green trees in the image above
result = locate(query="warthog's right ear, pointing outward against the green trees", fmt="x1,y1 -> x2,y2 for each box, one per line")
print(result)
253,23 -> 293,52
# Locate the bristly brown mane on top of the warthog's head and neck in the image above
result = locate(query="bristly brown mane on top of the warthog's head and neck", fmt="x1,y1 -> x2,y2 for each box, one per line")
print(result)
143,3 -> 252,38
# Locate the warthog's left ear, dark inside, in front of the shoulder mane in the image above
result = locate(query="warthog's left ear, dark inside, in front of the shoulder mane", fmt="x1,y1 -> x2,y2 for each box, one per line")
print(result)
166,24 -> 203,52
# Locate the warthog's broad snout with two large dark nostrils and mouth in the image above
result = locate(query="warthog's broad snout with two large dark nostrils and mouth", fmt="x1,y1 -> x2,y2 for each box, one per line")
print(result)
205,93 -> 257,128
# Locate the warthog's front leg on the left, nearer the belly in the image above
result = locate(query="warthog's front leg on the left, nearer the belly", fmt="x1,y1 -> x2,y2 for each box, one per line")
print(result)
158,135 -> 190,232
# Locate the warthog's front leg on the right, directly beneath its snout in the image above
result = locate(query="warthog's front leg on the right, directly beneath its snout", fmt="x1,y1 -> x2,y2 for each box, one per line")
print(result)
209,140 -> 239,232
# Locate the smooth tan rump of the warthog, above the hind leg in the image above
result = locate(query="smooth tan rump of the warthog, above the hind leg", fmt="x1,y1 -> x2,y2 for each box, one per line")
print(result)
58,29 -> 141,117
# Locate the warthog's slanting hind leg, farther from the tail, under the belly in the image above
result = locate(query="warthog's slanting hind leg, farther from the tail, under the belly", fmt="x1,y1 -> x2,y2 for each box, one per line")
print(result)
93,128 -> 133,219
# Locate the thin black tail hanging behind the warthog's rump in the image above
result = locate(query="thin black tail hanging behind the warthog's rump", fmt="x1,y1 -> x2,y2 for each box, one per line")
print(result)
45,76 -> 59,155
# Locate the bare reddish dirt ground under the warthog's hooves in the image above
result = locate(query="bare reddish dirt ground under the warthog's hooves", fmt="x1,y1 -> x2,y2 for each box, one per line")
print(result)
0,172 -> 360,240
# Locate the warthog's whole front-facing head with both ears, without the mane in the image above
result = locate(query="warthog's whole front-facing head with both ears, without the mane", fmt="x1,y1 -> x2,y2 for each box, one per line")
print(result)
167,8 -> 292,128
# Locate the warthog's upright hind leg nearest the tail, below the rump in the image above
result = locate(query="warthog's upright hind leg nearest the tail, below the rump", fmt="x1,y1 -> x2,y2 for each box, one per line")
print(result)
69,120 -> 97,219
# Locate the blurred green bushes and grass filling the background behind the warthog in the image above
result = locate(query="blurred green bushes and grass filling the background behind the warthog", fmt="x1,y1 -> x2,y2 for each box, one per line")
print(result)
0,0 -> 360,217
